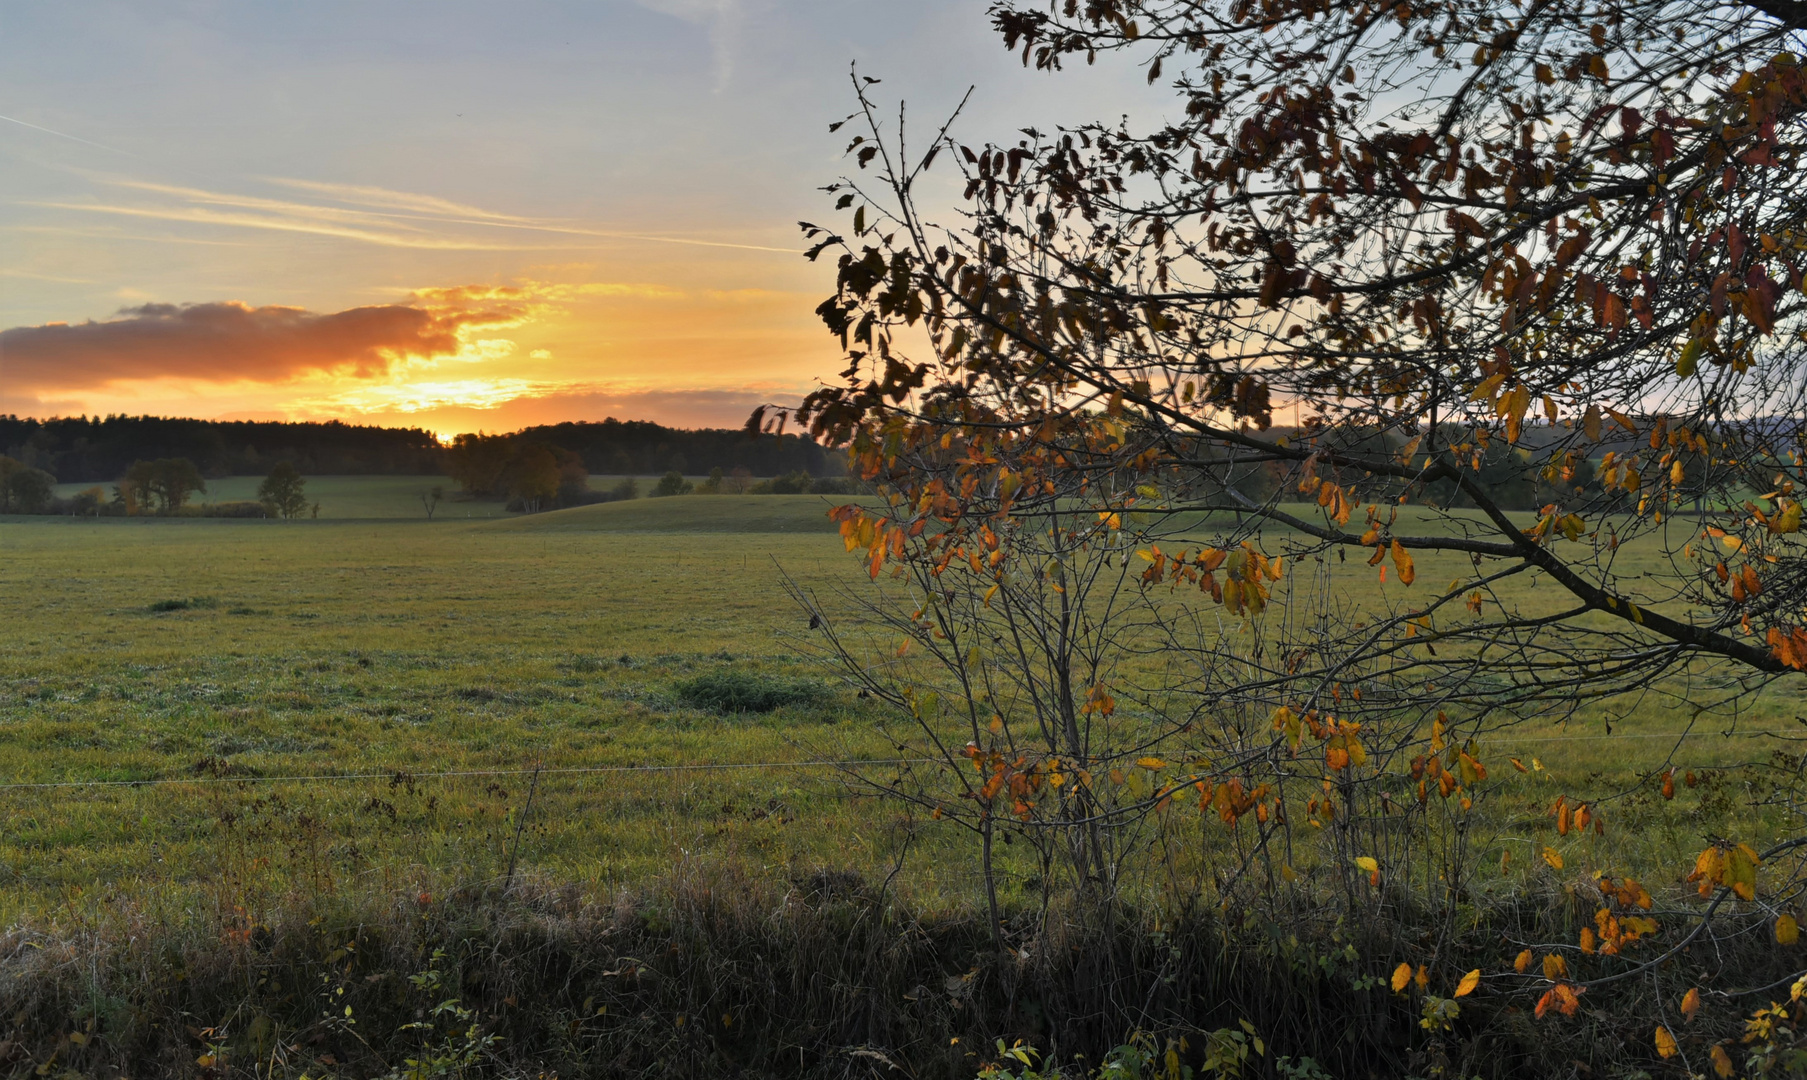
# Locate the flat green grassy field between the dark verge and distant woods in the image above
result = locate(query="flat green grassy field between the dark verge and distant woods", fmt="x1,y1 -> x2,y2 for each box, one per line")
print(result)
0,477 -> 1793,919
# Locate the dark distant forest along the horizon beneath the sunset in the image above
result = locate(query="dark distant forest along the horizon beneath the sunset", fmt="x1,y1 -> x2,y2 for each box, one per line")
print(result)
0,415 -> 846,484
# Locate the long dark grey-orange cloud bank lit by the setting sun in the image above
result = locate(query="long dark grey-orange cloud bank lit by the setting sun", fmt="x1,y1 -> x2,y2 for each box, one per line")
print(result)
0,285 -> 537,392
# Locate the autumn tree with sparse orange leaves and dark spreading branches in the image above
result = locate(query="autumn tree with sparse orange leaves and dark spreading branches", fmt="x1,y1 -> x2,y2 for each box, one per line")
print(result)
773,0 -> 1807,1075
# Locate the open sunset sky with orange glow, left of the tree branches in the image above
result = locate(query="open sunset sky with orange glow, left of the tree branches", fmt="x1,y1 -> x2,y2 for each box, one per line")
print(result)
0,0 -> 1151,435
